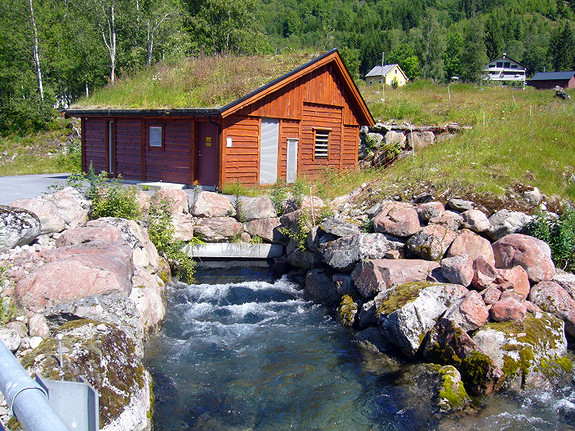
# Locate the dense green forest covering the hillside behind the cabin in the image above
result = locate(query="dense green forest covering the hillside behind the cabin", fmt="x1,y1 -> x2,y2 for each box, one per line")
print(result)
0,0 -> 575,135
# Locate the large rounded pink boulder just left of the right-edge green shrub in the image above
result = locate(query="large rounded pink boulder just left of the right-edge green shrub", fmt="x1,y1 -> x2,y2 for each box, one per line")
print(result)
493,234 -> 555,283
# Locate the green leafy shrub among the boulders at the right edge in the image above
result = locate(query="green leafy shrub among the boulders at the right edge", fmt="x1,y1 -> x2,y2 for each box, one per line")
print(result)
525,206 -> 575,272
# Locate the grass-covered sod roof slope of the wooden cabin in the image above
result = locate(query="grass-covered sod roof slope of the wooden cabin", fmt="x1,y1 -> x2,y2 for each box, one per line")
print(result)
72,52 -> 318,109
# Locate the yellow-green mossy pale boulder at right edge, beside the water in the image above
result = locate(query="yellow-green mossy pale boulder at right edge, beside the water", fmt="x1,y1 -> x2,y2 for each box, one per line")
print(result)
473,313 -> 571,389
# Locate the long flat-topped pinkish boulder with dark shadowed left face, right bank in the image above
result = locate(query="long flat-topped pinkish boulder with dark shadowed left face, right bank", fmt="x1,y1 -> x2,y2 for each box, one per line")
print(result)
351,259 -> 440,298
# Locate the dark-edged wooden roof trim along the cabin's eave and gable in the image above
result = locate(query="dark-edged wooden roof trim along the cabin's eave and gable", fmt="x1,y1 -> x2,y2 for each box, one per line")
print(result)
64,49 -> 375,125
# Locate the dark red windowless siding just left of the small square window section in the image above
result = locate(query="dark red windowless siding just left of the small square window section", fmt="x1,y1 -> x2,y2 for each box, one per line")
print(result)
116,119 -> 142,180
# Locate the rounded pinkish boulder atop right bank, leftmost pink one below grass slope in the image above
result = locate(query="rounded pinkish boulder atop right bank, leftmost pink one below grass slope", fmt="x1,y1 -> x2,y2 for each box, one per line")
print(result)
373,202 -> 421,237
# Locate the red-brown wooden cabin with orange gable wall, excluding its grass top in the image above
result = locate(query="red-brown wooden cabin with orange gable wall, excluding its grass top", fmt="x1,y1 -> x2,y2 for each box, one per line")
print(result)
65,50 -> 374,189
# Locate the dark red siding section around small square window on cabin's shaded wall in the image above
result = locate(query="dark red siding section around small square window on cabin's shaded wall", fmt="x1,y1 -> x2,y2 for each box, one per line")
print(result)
145,120 -> 193,184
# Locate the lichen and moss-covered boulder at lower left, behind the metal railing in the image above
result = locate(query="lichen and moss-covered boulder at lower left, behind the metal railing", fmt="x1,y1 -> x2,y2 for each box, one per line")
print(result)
22,320 -> 152,431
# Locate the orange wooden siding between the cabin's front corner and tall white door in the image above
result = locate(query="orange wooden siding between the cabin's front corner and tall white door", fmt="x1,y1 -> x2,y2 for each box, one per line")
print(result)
221,116 -> 260,185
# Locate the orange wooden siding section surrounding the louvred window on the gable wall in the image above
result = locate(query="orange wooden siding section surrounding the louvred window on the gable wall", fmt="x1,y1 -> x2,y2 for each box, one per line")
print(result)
298,104 -> 342,174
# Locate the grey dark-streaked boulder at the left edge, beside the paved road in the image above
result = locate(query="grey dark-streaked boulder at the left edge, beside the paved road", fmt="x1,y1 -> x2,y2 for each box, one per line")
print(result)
0,205 -> 42,253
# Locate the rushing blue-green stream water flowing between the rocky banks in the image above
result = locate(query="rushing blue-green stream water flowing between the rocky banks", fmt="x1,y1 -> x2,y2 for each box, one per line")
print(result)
146,268 -> 575,431
